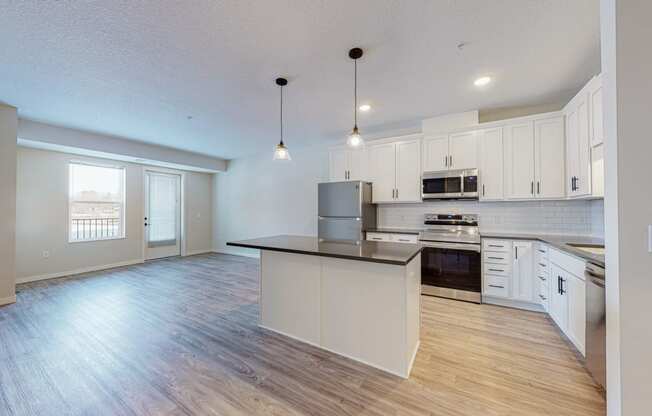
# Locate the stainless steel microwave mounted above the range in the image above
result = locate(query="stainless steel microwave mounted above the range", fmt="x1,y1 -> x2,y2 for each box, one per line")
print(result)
421,169 -> 478,199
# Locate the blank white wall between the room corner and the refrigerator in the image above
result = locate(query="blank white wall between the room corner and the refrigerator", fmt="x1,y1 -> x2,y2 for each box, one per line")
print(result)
213,147 -> 328,255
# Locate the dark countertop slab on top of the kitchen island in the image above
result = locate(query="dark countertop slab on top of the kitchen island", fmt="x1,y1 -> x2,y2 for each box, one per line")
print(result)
226,235 -> 421,266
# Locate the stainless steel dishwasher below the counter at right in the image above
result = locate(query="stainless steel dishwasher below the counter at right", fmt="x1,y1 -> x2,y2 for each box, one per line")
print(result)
584,262 -> 607,388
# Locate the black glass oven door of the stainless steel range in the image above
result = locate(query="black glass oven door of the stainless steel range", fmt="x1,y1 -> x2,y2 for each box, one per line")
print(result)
421,241 -> 482,302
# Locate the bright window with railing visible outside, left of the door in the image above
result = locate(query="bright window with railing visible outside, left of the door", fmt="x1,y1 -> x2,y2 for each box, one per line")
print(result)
69,162 -> 125,242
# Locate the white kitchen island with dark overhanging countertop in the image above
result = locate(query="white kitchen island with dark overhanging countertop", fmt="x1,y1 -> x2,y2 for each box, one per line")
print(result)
227,235 -> 421,378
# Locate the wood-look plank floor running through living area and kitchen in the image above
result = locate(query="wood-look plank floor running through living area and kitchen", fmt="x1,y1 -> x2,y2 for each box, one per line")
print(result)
0,254 -> 605,416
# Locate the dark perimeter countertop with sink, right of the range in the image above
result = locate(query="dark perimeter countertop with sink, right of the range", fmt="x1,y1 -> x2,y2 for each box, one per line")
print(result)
480,231 -> 604,267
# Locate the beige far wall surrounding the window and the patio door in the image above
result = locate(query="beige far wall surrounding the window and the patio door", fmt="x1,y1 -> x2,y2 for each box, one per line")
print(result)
16,147 -> 212,282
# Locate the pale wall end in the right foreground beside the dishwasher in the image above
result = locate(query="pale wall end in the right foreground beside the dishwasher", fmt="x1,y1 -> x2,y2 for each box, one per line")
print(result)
600,0 -> 652,416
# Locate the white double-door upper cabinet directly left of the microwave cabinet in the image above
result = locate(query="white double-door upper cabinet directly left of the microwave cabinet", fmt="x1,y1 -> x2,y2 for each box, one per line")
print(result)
368,139 -> 421,203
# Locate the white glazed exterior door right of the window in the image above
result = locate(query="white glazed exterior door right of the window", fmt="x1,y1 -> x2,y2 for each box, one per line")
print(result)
145,172 -> 181,260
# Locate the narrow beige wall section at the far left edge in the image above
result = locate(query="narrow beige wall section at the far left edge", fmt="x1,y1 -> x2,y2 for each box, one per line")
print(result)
0,105 -> 17,305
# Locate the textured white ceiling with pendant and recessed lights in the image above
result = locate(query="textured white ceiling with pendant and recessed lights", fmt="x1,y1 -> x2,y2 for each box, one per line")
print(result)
0,0 -> 600,158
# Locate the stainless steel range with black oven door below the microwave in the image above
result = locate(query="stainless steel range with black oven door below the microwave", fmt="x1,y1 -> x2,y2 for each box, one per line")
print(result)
420,214 -> 482,303
